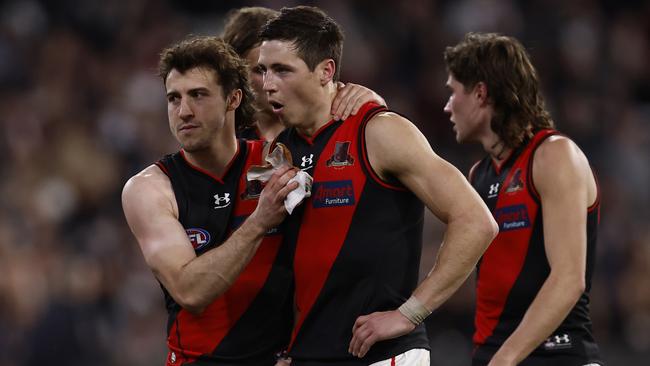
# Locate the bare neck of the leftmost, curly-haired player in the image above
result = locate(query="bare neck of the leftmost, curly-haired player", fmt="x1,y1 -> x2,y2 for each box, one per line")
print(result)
185,122 -> 238,177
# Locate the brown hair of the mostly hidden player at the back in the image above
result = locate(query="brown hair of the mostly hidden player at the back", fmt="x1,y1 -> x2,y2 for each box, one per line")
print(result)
223,6 -> 279,57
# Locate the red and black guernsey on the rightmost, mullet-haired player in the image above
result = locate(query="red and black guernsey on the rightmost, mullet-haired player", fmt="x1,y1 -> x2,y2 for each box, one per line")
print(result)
470,129 -> 600,365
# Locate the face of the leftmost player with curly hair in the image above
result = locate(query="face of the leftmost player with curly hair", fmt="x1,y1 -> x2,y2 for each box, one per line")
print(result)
165,67 -> 226,152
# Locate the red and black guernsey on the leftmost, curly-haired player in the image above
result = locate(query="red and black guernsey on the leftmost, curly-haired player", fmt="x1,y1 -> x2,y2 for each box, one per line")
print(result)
156,140 -> 293,366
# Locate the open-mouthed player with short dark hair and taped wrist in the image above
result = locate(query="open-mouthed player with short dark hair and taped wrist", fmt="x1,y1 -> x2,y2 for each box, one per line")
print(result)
259,6 -> 496,366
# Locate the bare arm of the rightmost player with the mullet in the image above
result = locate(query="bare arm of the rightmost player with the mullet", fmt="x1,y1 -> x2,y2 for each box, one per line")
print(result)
490,137 -> 596,366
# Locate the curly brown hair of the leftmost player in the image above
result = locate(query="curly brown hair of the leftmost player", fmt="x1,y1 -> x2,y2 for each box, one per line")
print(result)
158,37 -> 255,130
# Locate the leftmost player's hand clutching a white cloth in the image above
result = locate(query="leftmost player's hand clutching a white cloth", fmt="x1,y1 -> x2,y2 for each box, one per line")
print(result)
250,166 -> 298,231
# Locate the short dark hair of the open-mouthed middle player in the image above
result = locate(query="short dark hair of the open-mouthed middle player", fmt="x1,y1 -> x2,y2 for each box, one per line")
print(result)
260,6 -> 344,81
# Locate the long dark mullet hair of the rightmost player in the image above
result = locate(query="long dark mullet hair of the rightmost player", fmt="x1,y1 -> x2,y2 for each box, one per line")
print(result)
444,33 -> 554,148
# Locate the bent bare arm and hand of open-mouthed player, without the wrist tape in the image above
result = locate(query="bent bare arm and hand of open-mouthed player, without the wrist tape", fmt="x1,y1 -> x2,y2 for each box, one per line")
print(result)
350,113 -> 497,357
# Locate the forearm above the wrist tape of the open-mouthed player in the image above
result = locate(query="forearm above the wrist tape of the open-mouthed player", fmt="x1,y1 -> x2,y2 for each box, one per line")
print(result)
413,219 -> 496,311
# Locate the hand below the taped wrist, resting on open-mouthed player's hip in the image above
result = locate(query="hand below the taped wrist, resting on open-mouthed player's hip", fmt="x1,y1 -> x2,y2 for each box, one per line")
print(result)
348,310 -> 415,358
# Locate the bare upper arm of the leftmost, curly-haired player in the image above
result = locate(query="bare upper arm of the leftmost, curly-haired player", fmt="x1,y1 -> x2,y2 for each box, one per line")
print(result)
122,177 -> 196,290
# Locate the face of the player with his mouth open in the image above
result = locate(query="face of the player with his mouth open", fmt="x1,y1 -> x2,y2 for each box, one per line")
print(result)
259,40 -> 322,126
